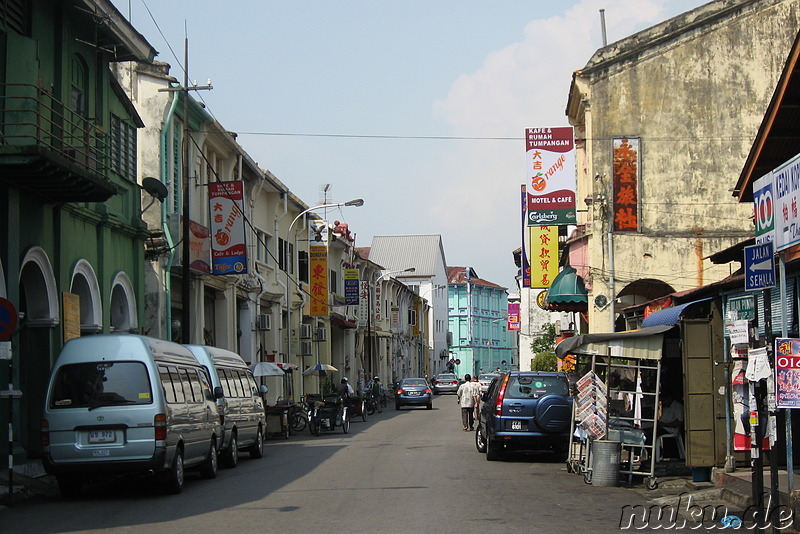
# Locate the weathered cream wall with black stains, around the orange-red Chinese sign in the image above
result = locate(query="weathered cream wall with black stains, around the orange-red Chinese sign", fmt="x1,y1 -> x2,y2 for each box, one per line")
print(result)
568,0 -> 800,331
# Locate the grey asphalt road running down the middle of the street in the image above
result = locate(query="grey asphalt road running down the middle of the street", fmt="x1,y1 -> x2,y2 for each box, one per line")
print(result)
0,395 -> 692,534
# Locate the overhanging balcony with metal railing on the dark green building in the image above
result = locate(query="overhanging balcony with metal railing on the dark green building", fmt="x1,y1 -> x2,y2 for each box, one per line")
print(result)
0,84 -> 119,203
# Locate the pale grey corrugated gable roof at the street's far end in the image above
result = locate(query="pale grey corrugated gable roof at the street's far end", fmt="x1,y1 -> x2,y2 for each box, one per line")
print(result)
369,234 -> 447,278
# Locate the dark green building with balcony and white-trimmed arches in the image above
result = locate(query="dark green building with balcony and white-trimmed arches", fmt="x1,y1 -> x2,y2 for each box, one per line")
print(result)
0,0 -> 156,465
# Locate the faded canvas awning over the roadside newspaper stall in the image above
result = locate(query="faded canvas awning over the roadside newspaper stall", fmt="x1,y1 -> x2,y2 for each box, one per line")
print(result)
556,325 -> 672,360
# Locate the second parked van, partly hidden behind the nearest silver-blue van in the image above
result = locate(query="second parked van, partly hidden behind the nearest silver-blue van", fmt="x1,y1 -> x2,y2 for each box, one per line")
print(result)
186,345 -> 267,467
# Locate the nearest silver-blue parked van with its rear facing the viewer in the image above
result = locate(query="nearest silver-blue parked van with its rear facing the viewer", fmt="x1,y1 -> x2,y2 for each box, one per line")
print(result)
42,334 -> 221,496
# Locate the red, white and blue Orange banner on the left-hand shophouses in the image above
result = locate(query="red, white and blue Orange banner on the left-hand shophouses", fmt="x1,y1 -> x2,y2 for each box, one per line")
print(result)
208,180 -> 247,274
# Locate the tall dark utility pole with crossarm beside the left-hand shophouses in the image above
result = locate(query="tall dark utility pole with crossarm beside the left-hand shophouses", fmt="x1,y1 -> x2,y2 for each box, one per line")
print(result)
159,36 -> 209,343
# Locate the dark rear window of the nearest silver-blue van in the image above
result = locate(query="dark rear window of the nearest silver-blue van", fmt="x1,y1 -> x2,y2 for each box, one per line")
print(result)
50,362 -> 153,408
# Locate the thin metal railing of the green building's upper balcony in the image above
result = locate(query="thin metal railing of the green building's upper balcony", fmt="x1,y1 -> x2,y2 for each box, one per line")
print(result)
0,83 -> 109,175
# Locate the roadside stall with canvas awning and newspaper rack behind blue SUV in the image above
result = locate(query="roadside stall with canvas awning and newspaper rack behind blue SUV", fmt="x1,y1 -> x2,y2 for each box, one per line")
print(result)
556,326 -> 672,489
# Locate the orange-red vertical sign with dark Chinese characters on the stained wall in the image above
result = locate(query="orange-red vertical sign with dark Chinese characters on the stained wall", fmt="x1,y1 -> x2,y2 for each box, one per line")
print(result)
612,138 -> 640,232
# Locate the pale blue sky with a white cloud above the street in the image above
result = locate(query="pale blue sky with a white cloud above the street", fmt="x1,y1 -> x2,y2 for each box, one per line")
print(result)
112,0 -> 706,294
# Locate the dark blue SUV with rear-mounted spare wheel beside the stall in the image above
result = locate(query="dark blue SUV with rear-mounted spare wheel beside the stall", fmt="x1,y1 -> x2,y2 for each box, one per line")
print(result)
475,371 -> 572,460
